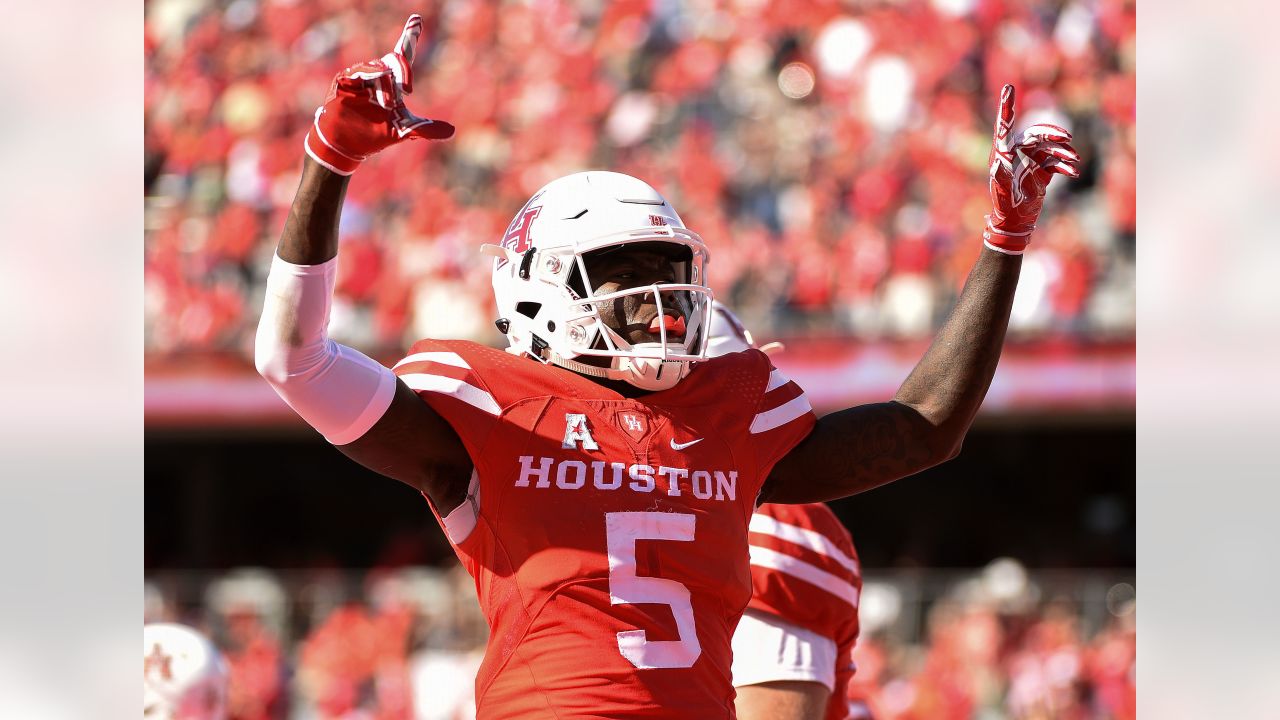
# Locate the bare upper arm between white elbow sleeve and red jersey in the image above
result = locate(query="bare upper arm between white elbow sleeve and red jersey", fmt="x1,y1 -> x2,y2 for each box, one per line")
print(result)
337,378 -> 472,515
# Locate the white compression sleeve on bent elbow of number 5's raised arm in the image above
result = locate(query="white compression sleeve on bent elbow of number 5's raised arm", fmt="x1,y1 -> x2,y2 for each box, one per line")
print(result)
253,256 -> 396,445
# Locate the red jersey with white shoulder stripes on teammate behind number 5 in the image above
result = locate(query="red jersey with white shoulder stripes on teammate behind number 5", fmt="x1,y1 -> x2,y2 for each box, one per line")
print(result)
749,502 -> 863,720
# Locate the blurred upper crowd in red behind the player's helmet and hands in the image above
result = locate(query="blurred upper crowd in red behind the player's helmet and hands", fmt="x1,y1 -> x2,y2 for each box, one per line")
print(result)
145,0 -> 1137,355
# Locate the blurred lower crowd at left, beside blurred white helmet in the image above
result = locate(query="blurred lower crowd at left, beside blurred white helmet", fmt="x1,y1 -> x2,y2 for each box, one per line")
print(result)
145,568 -> 486,720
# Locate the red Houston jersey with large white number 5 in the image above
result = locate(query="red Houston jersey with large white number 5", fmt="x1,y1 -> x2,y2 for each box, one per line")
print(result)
396,341 -> 814,719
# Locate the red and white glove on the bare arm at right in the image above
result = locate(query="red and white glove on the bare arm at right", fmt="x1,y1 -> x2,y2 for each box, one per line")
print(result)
982,85 -> 1080,255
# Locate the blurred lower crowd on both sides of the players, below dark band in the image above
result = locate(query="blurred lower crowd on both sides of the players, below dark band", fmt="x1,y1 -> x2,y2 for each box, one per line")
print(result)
146,560 -> 1137,720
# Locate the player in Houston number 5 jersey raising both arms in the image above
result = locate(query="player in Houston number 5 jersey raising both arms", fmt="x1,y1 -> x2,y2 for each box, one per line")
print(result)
256,15 -> 1075,719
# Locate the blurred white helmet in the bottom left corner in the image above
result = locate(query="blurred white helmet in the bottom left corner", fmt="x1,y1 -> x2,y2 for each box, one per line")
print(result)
142,623 -> 227,720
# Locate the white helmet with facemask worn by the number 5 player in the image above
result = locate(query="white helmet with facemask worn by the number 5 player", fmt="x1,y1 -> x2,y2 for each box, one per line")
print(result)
481,170 -> 714,391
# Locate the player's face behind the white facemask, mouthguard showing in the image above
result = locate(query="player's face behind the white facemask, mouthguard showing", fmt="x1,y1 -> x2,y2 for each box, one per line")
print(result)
582,246 -> 692,343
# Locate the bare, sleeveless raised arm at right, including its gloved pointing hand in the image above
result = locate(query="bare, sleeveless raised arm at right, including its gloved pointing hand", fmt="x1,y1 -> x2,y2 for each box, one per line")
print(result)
762,85 -> 1079,502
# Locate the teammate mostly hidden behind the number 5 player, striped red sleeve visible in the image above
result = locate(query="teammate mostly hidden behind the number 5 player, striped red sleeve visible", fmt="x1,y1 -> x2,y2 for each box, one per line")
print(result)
708,302 -> 870,720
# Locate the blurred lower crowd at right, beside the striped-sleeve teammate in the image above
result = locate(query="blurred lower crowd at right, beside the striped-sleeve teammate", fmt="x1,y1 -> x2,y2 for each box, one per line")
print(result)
850,559 -> 1137,720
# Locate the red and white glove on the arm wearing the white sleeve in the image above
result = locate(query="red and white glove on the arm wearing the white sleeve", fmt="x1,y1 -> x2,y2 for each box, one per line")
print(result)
306,14 -> 453,176
